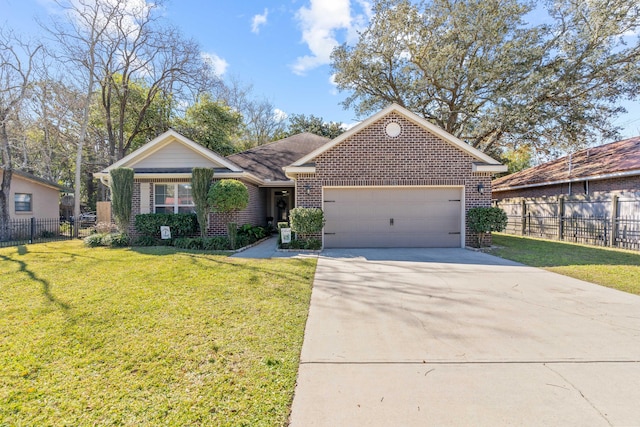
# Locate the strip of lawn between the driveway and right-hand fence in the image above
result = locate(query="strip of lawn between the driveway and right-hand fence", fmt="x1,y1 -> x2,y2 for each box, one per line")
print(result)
491,234 -> 640,295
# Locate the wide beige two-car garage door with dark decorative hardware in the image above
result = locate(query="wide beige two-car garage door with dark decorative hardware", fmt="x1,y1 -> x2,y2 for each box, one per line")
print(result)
324,187 -> 462,248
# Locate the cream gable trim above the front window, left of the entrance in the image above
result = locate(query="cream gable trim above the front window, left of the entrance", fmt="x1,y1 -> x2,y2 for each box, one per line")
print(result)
98,129 -> 242,175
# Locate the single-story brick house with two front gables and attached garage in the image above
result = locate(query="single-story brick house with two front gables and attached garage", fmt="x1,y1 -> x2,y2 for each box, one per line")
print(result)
95,104 -> 506,247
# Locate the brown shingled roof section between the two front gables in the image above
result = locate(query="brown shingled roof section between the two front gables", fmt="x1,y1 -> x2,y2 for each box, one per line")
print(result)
227,132 -> 331,181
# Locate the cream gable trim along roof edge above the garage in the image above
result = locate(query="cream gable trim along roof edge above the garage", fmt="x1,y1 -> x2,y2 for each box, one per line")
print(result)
285,104 -> 506,173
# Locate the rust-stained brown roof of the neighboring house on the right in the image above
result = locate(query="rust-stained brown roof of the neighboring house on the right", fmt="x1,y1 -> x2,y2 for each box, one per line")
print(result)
492,136 -> 640,191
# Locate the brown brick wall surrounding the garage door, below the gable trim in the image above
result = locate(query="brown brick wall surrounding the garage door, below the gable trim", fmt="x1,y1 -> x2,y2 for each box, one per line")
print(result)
296,113 -> 491,245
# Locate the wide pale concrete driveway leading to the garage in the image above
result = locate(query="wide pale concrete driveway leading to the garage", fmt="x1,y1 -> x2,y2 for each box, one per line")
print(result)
290,249 -> 640,427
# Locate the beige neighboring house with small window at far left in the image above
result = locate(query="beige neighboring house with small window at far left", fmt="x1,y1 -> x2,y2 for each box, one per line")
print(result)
0,169 -> 69,219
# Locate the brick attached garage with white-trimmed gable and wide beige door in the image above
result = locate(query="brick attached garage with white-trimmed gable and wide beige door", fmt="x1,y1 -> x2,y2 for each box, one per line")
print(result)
284,104 -> 507,248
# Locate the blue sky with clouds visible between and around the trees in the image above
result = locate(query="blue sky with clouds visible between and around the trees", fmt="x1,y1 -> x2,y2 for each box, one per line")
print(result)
0,0 -> 640,137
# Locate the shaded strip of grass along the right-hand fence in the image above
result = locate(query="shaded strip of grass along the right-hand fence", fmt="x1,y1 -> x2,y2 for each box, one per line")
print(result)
489,235 -> 640,267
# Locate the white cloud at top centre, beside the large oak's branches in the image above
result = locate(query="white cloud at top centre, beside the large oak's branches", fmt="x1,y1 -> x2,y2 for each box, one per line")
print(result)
292,0 -> 371,75
